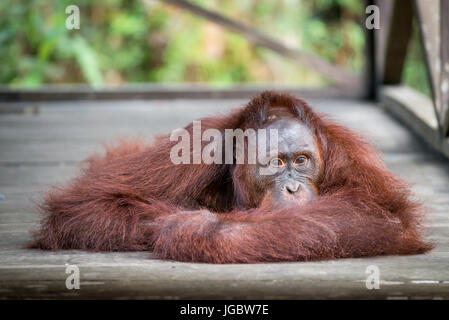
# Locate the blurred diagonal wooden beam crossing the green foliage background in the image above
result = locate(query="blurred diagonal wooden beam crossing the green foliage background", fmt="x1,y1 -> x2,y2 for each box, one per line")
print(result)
162,0 -> 360,87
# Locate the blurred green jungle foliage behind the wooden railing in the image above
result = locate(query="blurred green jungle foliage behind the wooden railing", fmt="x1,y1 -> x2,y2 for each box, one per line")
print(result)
0,0 -> 428,93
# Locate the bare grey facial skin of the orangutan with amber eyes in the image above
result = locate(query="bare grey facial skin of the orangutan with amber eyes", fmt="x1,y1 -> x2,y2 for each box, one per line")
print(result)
248,117 -> 323,207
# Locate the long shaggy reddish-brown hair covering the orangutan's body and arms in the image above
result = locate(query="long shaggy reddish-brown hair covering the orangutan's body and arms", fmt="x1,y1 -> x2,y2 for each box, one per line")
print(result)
29,92 -> 431,263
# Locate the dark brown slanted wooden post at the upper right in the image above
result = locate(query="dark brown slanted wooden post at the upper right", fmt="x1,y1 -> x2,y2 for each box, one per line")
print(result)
382,0 -> 413,85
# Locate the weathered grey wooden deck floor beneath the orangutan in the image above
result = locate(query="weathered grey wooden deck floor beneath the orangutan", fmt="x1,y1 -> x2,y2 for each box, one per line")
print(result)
0,100 -> 449,299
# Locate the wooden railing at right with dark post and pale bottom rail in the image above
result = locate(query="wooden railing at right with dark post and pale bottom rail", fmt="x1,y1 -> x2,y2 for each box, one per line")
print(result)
376,0 -> 449,156
